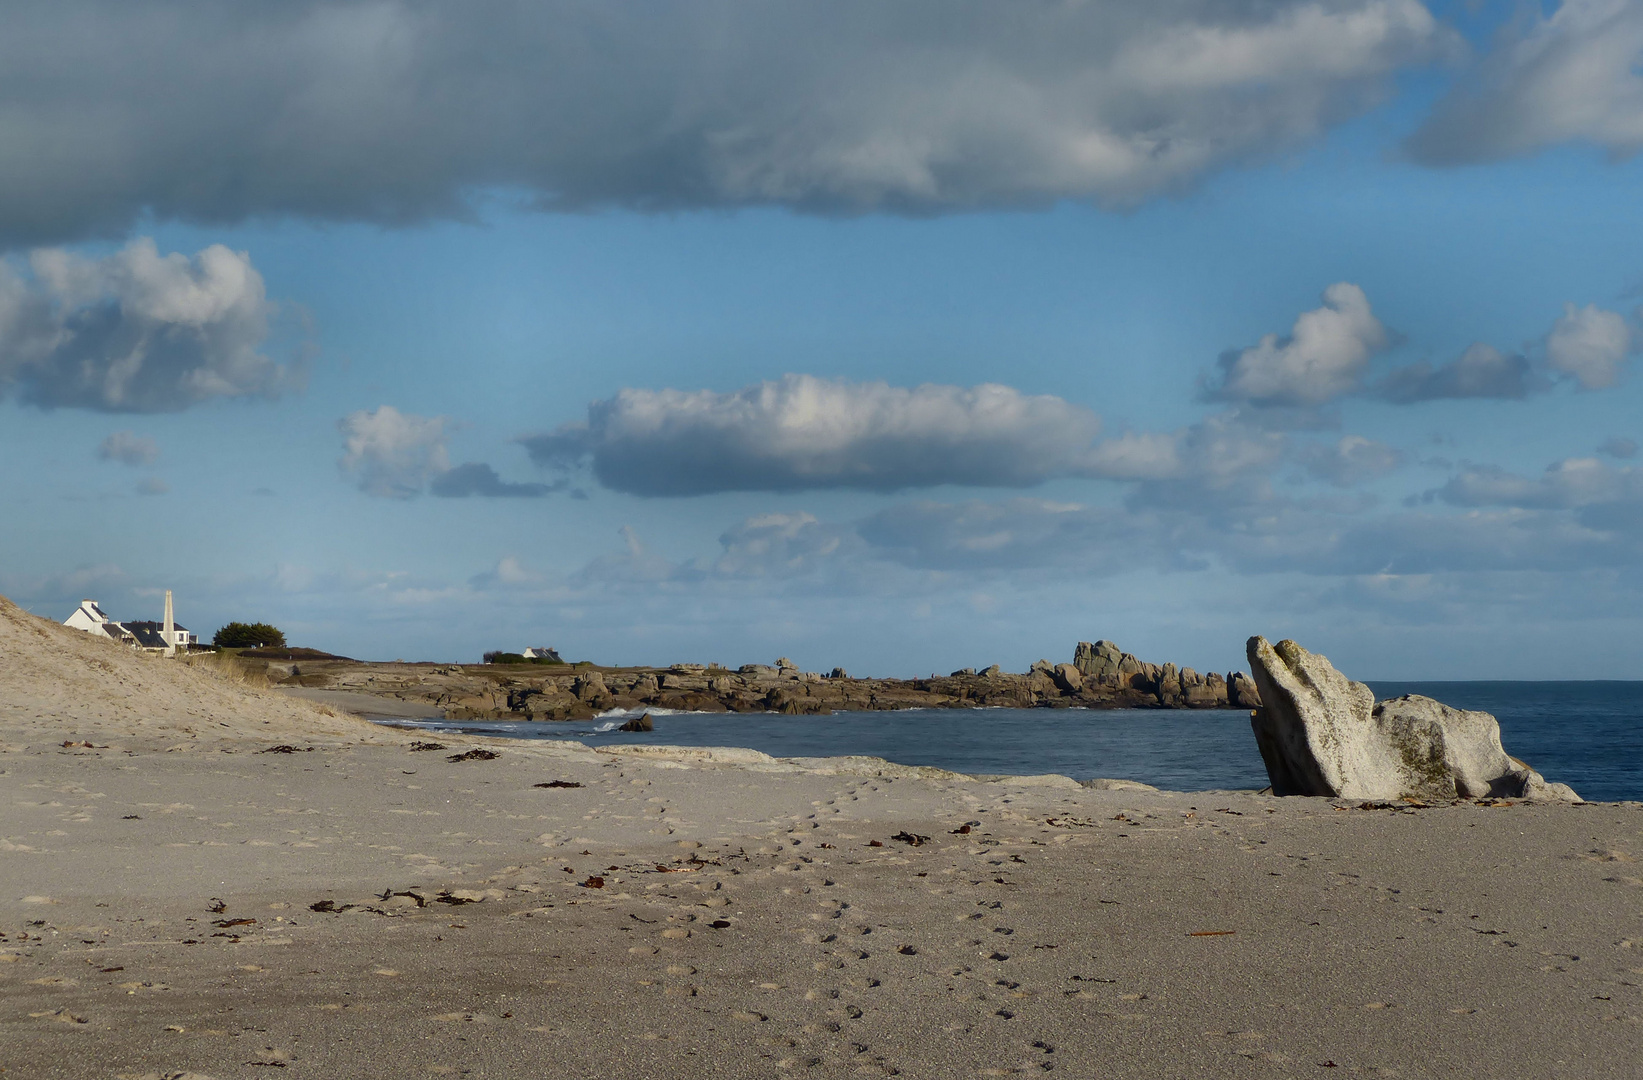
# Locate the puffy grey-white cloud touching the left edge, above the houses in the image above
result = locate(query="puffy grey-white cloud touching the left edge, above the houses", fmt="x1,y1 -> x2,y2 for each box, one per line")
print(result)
0,238 -> 297,413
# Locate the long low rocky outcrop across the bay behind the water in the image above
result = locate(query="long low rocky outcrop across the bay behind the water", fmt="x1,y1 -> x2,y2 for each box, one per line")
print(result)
269,641 -> 1260,720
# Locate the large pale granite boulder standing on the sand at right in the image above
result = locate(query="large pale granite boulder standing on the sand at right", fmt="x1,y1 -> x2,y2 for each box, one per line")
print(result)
1249,638 -> 1579,802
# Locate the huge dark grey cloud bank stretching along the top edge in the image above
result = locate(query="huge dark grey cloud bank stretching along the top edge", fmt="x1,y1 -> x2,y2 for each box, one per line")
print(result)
0,0 -> 1452,245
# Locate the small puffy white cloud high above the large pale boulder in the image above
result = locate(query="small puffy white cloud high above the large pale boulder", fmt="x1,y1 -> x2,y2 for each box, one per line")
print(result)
1208,281 -> 1388,408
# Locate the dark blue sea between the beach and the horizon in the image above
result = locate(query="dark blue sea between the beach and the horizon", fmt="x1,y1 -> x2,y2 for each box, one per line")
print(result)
378,682 -> 1643,802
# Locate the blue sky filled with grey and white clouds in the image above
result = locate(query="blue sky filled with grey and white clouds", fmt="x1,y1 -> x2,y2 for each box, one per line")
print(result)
0,0 -> 1643,679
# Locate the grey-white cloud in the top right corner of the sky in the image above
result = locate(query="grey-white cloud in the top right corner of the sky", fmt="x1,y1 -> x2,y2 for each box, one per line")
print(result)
1408,0 -> 1643,164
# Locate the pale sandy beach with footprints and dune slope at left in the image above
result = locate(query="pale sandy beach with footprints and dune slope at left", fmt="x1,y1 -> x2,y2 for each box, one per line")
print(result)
0,603 -> 1643,1080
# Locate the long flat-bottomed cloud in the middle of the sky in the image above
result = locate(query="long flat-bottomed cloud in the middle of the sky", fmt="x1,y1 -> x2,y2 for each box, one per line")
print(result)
521,375 -> 1101,495
